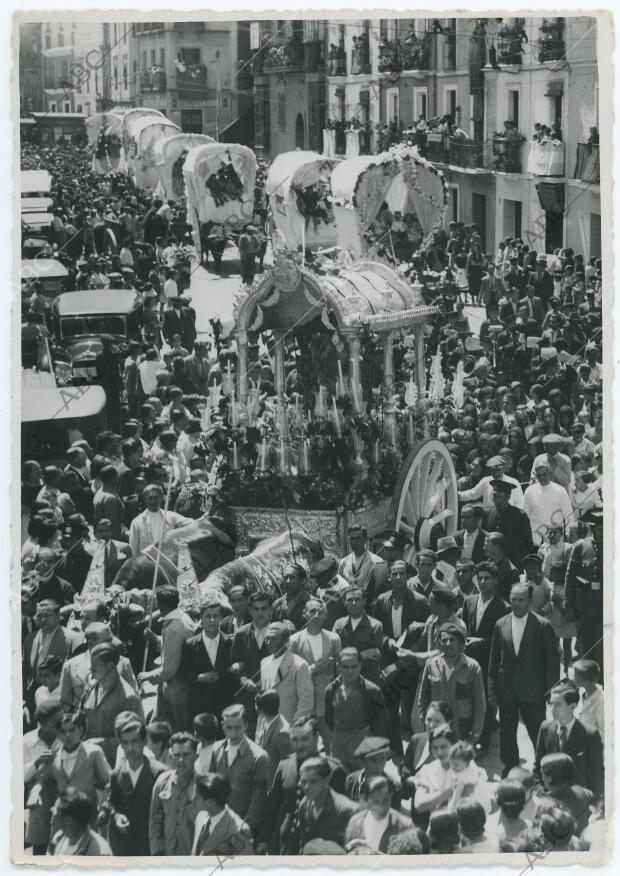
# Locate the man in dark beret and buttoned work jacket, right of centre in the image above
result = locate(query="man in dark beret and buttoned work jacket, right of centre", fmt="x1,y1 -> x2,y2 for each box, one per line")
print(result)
417,623 -> 486,745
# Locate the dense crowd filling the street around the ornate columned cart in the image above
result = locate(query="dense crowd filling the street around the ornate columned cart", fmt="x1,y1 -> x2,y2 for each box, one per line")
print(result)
21,137 -> 605,858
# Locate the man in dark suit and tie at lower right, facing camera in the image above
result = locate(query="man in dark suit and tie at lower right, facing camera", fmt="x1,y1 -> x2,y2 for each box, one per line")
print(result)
534,681 -> 605,799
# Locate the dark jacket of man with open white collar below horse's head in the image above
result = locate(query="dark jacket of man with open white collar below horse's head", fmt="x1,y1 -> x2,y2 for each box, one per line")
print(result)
180,632 -> 236,720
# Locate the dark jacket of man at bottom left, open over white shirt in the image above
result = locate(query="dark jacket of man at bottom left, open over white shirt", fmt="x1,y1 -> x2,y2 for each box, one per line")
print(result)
110,757 -> 168,855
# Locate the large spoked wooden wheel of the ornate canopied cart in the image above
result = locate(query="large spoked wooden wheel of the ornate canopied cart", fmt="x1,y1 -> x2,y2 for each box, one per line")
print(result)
392,439 -> 458,561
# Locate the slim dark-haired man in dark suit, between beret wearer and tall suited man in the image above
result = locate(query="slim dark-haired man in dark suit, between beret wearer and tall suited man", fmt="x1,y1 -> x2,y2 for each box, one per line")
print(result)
461,560 -> 510,751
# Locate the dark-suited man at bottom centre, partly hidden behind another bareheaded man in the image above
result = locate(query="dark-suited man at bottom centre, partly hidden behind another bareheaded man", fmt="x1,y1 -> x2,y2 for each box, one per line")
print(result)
256,718 -> 346,855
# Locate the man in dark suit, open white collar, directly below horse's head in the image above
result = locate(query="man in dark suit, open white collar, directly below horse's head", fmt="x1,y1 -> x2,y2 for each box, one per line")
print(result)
181,599 -> 235,721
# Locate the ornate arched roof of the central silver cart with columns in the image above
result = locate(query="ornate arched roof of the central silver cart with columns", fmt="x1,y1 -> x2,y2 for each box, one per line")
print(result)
235,253 -> 436,332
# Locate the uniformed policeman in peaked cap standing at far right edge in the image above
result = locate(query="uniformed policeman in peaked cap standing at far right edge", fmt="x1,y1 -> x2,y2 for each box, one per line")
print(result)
563,508 -> 603,678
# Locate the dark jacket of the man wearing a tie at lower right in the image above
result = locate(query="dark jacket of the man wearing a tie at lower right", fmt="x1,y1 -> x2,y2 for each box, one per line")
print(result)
534,719 -> 605,797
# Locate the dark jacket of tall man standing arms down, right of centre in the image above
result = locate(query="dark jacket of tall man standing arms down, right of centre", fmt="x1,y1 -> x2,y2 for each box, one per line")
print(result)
489,611 -> 560,704
